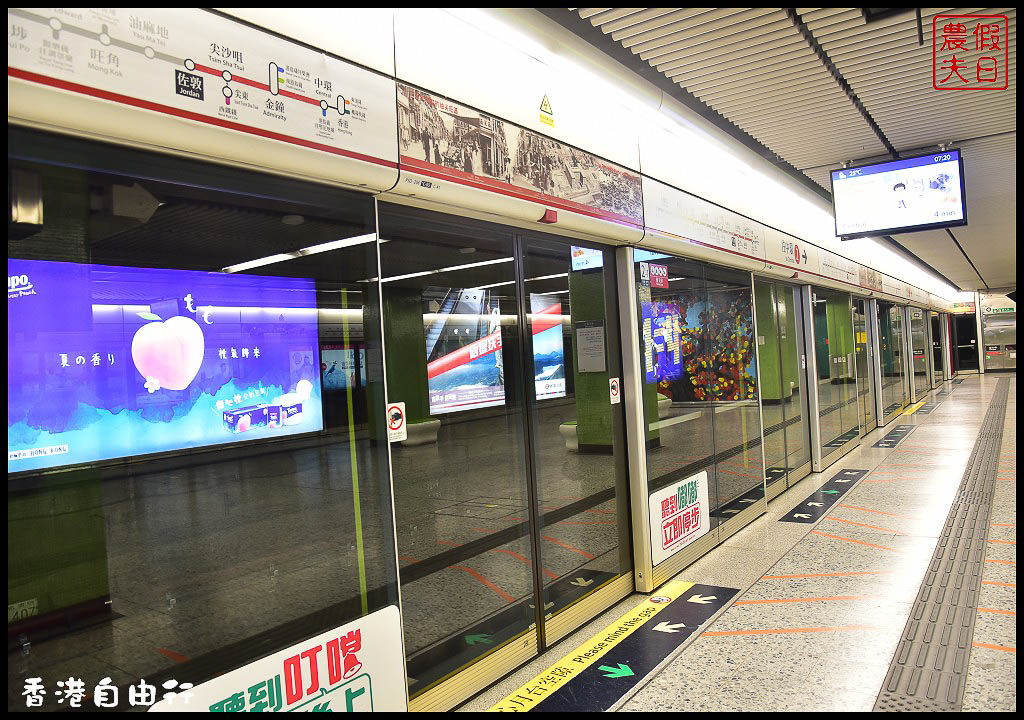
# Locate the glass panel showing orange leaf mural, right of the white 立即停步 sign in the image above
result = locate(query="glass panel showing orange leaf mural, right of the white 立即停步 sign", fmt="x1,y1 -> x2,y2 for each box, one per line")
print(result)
703,265 -> 765,510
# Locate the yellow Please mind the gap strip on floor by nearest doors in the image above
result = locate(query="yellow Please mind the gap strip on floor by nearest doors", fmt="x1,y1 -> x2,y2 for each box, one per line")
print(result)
487,580 -> 694,713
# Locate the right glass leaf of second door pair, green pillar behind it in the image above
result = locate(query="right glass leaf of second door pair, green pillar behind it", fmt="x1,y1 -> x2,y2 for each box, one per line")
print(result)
775,284 -> 811,481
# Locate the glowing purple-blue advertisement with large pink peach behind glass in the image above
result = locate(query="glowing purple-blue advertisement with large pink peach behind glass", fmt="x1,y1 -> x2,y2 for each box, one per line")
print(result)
7,260 -> 323,472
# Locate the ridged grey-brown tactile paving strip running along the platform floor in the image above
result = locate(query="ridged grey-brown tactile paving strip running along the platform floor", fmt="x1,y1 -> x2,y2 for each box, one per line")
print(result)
874,379 -> 1010,712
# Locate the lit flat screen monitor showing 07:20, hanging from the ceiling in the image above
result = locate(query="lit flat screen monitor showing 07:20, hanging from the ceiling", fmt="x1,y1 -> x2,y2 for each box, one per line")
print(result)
831,150 -> 967,240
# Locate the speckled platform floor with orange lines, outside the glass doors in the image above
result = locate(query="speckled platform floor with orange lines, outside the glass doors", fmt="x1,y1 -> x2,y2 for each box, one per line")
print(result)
461,375 -> 1017,712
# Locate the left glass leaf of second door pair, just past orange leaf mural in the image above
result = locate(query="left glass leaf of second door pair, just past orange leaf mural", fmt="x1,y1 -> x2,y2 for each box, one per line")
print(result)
754,280 -> 793,485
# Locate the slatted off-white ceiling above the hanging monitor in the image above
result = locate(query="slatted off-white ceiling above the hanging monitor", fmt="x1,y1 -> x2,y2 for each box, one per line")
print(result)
570,7 -> 1017,290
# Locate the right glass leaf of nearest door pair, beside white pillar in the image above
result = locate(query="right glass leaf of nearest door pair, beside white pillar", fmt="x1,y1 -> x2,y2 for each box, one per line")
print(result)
523,238 -> 633,616
